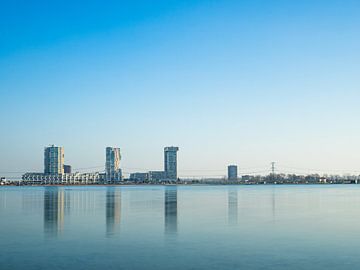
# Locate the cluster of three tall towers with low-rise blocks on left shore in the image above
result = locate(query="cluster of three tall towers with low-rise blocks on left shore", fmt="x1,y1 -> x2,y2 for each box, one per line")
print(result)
22,144 -> 183,185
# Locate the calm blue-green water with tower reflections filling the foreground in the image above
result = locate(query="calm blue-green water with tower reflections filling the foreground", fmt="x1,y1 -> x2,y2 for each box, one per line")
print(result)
0,185 -> 360,270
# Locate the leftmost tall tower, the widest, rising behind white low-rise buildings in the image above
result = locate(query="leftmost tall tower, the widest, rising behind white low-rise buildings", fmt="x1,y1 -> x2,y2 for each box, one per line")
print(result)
44,145 -> 64,174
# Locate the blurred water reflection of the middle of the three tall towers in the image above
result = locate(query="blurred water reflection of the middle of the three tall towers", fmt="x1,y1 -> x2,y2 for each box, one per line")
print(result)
106,187 -> 121,236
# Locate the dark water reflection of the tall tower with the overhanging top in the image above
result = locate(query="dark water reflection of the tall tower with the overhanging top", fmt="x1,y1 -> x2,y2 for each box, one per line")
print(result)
164,187 -> 177,234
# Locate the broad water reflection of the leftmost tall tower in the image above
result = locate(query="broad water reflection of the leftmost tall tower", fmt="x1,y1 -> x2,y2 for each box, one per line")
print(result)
44,187 -> 70,236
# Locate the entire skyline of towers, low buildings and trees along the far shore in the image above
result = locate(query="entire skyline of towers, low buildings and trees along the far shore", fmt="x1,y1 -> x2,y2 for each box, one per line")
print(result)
13,144 -> 360,185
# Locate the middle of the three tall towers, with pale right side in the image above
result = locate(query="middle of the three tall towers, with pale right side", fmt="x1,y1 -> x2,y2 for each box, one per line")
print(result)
105,147 -> 122,182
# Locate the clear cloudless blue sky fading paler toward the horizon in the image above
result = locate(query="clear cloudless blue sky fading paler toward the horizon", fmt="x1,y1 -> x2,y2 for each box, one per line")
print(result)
0,0 -> 360,179
